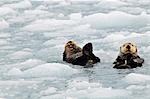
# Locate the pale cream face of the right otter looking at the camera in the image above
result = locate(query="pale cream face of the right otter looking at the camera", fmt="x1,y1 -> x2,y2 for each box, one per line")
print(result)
120,43 -> 137,54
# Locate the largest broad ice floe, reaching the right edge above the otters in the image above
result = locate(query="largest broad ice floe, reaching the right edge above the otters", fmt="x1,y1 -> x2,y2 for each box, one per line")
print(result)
82,11 -> 150,29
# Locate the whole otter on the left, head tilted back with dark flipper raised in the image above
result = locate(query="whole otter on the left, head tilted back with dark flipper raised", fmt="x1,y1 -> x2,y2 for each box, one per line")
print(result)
63,41 -> 100,67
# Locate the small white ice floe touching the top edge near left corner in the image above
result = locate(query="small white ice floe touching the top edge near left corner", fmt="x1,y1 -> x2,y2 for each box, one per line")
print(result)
3,0 -> 32,9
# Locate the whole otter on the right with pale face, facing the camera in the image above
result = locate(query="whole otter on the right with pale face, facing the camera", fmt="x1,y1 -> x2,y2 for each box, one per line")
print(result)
113,43 -> 144,69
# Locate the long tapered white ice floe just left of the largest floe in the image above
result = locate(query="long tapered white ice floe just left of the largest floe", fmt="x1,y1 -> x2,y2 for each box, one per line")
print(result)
22,19 -> 76,32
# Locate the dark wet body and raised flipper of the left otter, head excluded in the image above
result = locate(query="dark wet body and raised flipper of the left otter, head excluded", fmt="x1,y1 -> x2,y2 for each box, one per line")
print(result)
63,43 -> 100,67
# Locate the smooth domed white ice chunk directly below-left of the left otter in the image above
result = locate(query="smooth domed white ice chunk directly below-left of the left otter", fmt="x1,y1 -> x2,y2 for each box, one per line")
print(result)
23,63 -> 78,77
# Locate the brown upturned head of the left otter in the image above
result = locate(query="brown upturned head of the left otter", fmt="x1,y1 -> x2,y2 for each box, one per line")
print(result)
65,41 -> 77,54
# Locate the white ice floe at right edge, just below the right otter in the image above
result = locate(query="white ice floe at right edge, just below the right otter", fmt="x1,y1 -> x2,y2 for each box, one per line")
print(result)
123,73 -> 150,84
